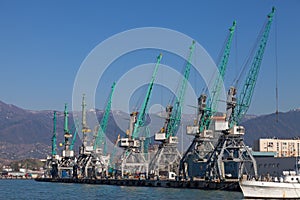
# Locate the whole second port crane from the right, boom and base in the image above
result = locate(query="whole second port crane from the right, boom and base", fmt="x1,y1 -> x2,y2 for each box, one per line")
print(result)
179,21 -> 236,179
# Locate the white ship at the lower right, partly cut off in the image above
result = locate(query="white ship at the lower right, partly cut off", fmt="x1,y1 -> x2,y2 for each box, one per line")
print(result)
240,171 -> 300,199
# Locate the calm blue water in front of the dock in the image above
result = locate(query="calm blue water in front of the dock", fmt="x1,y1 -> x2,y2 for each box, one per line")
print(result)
0,180 -> 243,200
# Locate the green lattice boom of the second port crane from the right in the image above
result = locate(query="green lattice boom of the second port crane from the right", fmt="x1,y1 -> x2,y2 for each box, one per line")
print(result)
199,21 -> 236,133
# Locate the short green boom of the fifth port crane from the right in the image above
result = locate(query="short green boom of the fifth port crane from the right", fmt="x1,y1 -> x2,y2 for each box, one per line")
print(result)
94,82 -> 116,155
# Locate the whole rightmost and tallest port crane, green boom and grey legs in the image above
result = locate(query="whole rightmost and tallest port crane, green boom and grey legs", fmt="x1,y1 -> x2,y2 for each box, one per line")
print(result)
206,7 -> 275,181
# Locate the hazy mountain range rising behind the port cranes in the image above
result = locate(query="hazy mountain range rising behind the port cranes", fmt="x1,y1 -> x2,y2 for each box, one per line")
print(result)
0,101 -> 300,163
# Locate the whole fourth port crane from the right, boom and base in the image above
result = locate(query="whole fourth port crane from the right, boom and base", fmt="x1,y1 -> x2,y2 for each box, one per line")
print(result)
119,54 -> 162,178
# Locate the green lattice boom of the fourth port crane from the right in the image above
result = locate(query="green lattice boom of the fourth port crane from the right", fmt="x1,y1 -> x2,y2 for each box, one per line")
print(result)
132,54 -> 162,139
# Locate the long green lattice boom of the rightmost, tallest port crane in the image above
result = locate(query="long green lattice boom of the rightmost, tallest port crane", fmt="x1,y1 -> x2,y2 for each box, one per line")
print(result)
229,7 -> 275,128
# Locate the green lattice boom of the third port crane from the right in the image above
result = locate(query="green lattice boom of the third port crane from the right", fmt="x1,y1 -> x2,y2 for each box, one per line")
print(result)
166,41 -> 195,138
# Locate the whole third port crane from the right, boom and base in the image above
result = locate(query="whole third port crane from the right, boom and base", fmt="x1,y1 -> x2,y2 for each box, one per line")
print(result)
149,41 -> 195,177
